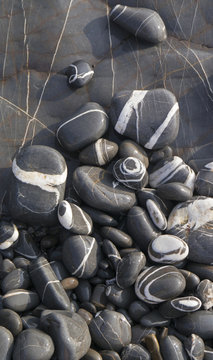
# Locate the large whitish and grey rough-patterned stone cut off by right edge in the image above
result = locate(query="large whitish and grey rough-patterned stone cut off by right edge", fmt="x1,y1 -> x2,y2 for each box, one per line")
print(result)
167,197 -> 213,264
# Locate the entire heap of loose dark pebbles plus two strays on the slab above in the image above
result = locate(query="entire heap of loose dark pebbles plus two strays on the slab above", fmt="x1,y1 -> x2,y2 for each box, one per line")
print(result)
0,5 -> 213,360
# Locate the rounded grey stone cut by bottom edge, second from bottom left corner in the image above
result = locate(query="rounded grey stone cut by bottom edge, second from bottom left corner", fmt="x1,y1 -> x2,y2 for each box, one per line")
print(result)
13,329 -> 55,360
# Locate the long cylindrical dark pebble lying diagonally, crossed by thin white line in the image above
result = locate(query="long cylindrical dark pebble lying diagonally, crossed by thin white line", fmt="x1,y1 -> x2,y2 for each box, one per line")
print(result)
29,256 -> 70,310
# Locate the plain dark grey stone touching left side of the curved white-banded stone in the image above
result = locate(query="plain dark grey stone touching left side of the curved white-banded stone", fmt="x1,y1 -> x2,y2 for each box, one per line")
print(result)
116,251 -> 146,289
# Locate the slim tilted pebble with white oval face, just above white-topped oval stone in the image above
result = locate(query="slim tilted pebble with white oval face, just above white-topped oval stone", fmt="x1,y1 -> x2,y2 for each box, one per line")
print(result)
146,199 -> 167,230
